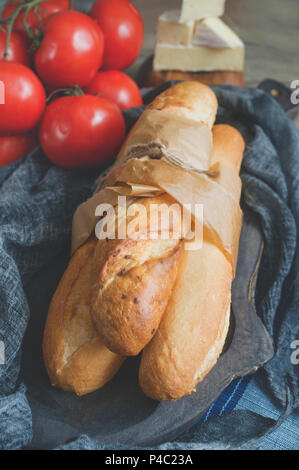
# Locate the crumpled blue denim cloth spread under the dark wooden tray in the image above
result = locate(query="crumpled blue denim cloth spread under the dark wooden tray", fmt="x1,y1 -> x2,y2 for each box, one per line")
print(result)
0,82 -> 299,449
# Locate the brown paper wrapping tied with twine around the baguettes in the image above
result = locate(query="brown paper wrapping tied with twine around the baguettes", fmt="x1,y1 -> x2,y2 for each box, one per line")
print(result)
72,110 -> 242,272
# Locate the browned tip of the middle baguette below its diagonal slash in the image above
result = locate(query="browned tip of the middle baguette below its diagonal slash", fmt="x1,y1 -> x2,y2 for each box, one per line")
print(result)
93,245 -> 181,356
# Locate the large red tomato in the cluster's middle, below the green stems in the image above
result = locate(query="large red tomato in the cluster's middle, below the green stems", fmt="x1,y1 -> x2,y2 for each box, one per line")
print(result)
35,11 -> 104,88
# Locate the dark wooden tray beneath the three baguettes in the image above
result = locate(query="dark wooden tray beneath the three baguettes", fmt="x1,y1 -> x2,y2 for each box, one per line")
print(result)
22,207 -> 273,449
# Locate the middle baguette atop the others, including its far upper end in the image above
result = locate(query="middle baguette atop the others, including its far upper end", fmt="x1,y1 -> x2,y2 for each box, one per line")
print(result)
91,82 -> 217,356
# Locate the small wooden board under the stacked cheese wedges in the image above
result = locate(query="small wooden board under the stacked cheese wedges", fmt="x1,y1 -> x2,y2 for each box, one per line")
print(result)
137,56 -> 245,88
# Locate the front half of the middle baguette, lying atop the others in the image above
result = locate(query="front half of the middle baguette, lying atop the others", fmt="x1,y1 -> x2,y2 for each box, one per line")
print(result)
91,194 -> 183,356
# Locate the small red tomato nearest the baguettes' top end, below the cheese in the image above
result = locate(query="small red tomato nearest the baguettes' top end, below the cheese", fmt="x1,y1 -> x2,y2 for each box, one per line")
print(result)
85,70 -> 142,109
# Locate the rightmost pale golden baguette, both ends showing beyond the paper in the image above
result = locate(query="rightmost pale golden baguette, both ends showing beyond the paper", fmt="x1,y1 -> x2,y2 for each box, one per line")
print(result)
139,125 -> 244,401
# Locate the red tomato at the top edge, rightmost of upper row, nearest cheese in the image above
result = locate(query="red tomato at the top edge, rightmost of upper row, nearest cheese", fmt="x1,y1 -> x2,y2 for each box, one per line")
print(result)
90,0 -> 144,70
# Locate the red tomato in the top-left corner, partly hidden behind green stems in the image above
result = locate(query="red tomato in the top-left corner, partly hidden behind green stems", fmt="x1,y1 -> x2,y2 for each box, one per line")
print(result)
1,0 -> 69,39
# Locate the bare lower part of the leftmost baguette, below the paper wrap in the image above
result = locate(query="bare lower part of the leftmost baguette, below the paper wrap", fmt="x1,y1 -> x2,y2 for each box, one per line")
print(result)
43,237 -> 124,395
